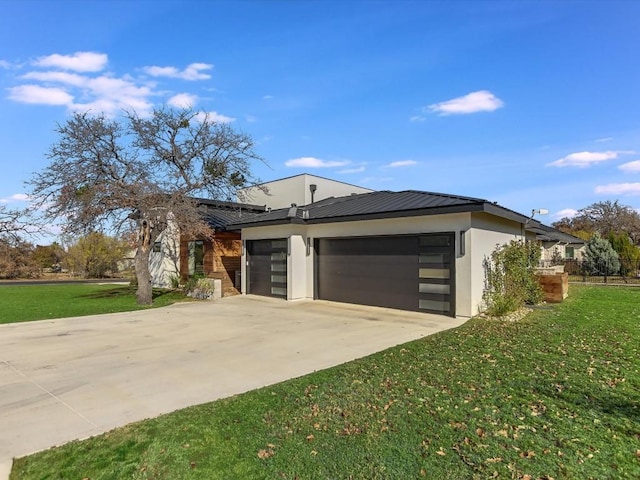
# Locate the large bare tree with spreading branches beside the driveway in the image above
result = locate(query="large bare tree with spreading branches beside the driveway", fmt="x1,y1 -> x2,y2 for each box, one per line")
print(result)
29,108 -> 262,304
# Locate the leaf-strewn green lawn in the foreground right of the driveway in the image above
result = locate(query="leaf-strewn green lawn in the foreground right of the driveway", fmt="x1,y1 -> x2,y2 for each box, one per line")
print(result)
10,286 -> 640,480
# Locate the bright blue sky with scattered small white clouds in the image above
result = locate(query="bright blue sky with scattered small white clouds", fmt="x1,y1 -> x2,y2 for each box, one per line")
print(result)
0,0 -> 640,238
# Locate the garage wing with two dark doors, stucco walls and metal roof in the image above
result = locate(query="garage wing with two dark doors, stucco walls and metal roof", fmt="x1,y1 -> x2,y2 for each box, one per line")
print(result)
228,191 -> 528,317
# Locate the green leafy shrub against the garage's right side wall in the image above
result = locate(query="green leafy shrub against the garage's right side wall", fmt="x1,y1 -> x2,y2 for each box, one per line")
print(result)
483,240 -> 543,317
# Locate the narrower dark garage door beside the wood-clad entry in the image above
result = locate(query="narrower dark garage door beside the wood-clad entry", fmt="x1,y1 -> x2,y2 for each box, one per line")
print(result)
247,238 -> 287,298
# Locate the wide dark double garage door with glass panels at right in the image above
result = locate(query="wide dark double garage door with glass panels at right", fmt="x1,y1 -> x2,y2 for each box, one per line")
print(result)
315,233 -> 455,316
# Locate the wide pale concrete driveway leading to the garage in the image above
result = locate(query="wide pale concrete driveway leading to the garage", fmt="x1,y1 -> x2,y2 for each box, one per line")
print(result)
0,296 -> 463,479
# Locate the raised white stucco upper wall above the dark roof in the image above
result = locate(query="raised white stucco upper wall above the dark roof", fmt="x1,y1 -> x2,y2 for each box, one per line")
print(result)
237,174 -> 373,210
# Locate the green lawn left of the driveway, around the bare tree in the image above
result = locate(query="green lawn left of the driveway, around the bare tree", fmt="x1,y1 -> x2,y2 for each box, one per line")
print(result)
0,284 -> 190,323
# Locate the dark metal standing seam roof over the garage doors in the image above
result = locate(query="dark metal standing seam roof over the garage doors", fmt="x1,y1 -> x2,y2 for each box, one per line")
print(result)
229,190 -> 527,228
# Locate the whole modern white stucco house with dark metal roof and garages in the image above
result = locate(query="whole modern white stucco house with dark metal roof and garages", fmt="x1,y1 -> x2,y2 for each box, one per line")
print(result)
152,174 -> 579,317
